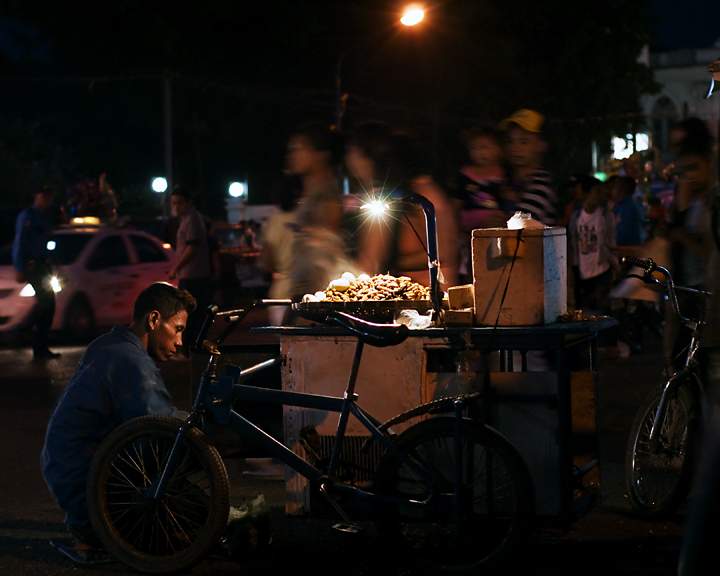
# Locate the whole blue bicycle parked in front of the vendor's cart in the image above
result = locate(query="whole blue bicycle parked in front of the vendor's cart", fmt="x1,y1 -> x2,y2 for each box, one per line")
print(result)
88,300 -> 534,574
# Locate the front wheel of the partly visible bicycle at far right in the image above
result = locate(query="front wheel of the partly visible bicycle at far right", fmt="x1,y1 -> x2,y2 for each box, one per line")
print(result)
625,376 -> 701,520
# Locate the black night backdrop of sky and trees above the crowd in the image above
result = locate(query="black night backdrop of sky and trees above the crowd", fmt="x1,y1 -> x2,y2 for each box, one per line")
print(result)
0,0 -> 720,225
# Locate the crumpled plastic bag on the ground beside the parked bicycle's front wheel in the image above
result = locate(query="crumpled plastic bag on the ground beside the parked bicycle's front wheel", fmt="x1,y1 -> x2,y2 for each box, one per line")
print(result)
221,494 -> 272,561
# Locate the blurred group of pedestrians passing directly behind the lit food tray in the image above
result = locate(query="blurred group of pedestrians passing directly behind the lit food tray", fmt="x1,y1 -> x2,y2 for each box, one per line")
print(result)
261,110 -> 557,322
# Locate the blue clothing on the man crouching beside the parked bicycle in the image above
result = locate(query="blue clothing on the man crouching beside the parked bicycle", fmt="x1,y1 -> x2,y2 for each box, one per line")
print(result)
40,324 -> 177,526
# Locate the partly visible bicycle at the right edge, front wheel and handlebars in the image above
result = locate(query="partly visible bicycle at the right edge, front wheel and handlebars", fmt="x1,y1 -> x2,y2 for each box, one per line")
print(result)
624,257 -> 711,520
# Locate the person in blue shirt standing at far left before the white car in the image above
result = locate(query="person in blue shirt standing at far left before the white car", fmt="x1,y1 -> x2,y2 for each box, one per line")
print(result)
13,186 -> 60,360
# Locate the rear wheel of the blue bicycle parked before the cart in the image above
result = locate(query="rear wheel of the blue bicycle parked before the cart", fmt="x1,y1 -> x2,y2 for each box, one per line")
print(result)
375,417 -> 534,574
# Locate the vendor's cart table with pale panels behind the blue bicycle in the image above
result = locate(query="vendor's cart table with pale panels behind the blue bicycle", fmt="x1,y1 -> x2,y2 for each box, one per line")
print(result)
252,317 -> 616,521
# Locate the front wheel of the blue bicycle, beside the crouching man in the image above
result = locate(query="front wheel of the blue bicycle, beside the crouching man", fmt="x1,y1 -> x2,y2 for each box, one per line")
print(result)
87,416 -> 230,574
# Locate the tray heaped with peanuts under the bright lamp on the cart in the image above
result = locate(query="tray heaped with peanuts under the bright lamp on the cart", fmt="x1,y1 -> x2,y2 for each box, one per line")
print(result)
293,272 -> 432,323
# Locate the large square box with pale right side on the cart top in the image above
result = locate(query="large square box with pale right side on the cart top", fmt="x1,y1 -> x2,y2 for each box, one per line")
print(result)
472,227 -> 567,326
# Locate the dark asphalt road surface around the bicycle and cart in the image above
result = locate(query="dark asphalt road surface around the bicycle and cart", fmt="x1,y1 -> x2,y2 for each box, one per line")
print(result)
0,320 -> 684,576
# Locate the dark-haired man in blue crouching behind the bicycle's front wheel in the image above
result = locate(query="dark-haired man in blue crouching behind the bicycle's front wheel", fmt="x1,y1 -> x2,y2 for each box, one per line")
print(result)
40,282 -> 195,564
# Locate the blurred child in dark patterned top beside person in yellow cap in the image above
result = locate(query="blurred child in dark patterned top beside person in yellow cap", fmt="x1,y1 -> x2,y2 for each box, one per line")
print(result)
453,126 -> 513,283
